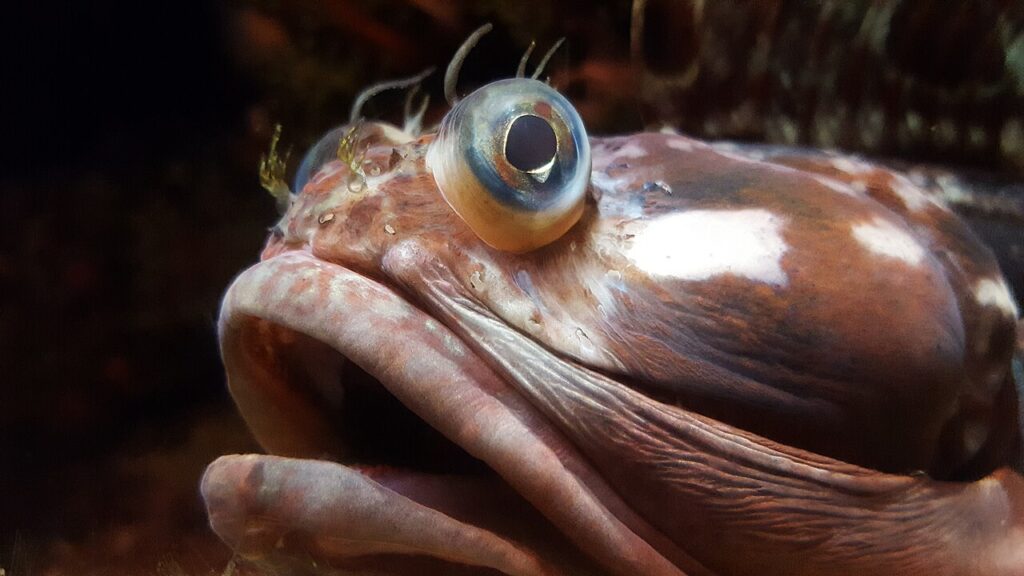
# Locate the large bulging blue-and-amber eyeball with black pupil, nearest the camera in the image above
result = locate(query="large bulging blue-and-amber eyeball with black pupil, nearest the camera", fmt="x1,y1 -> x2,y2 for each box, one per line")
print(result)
427,78 -> 591,252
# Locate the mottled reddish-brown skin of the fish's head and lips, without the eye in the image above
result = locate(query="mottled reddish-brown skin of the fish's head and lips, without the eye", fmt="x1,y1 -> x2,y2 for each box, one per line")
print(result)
203,118 -> 1024,576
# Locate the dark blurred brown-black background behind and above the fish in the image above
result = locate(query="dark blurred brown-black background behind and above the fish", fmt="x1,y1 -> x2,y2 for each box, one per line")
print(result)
0,0 -> 1024,576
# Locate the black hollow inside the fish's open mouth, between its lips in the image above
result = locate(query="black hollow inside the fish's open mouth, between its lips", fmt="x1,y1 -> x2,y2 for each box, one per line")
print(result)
259,321 -> 494,476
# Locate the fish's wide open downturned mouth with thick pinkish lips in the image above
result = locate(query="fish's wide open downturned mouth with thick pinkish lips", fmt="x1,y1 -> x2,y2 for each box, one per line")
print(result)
202,251 -> 681,575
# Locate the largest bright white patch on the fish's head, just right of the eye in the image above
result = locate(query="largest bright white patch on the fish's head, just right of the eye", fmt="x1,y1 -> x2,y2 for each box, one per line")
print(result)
626,209 -> 788,286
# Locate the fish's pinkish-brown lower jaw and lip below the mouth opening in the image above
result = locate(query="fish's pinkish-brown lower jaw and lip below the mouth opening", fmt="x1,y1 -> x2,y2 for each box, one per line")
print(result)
203,455 -> 602,576
